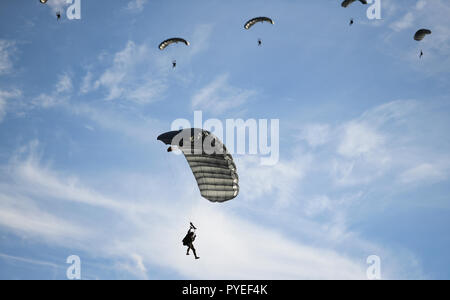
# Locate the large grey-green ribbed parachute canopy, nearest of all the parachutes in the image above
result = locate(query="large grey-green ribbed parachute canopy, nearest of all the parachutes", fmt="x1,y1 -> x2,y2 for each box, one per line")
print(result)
158,128 -> 239,202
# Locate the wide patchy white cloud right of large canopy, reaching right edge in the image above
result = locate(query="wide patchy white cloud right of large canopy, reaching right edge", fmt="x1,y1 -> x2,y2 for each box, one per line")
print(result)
298,101 -> 450,188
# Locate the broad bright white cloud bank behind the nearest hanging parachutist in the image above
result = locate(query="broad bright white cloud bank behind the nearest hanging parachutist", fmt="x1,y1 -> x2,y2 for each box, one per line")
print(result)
0,143 -> 388,279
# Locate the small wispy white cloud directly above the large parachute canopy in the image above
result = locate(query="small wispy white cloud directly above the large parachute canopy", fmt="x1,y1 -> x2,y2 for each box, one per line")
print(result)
191,74 -> 256,113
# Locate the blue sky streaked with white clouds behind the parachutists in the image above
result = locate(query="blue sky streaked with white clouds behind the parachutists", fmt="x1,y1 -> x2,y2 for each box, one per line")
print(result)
0,0 -> 450,279
